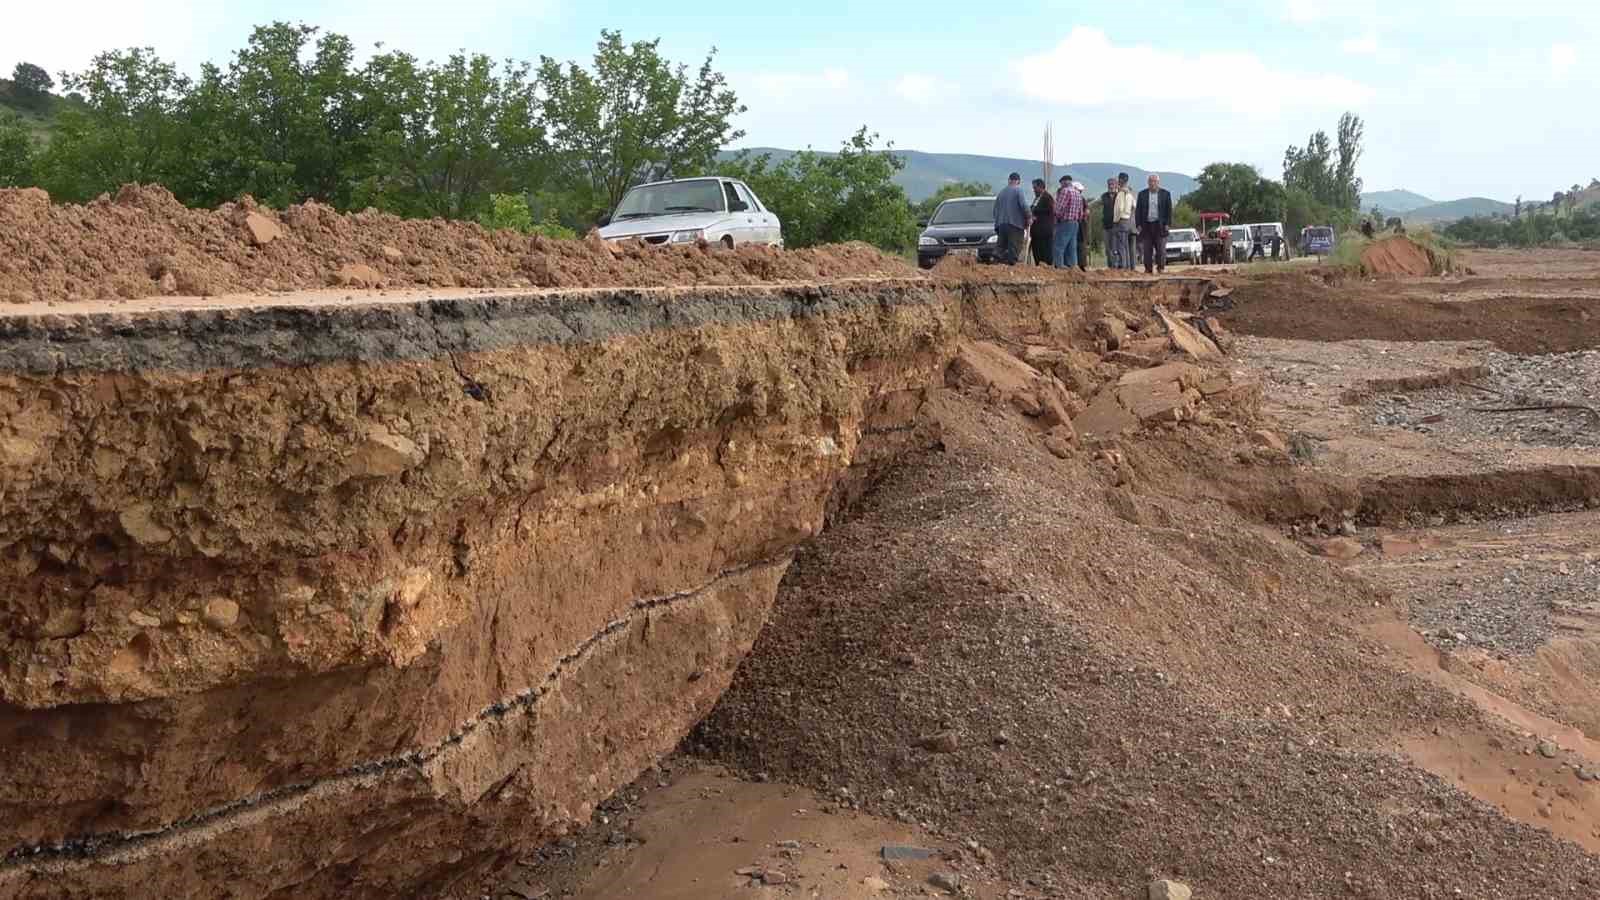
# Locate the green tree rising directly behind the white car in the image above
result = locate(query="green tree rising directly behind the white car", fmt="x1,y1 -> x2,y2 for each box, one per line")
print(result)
539,30 -> 744,220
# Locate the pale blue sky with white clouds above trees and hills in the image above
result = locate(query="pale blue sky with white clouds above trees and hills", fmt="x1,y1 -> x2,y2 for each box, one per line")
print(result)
0,0 -> 1600,200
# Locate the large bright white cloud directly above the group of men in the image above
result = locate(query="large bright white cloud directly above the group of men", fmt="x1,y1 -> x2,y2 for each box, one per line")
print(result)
1011,26 -> 1373,115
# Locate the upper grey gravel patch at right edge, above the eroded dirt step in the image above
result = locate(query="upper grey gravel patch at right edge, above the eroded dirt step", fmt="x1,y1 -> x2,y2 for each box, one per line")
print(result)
1368,351 -> 1600,448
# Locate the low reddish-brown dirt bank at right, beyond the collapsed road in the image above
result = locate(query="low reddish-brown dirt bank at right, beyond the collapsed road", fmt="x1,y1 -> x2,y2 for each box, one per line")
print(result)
1221,267 -> 1600,354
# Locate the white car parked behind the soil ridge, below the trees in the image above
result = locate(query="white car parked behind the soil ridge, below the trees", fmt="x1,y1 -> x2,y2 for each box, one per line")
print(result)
600,178 -> 784,248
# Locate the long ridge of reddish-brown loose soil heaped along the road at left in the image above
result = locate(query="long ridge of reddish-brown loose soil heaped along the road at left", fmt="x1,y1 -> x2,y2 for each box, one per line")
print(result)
0,184 -> 917,303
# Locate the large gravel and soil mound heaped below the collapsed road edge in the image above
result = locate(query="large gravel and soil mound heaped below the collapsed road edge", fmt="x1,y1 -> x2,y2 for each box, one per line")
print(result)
693,381 -> 1600,898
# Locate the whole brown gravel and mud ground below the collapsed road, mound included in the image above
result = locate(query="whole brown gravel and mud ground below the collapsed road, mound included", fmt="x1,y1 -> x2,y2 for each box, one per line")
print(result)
505,253 -> 1600,898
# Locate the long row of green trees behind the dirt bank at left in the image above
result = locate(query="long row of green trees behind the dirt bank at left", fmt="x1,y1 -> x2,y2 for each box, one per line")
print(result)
0,22 -> 744,224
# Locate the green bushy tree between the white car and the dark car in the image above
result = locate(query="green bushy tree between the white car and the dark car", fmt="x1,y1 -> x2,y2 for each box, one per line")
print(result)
722,127 -> 917,253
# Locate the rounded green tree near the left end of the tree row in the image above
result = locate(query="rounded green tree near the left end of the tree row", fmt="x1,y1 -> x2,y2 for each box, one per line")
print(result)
37,48 -> 190,202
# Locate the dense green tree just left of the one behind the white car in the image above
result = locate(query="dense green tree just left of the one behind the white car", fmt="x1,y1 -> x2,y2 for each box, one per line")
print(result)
358,53 -> 546,218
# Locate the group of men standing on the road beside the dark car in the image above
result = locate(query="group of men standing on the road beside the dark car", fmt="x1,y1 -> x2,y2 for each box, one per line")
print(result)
995,171 -> 1173,274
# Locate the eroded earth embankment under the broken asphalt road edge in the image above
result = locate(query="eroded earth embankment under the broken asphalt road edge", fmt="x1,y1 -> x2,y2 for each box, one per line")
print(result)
0,243 -> 1195,897
